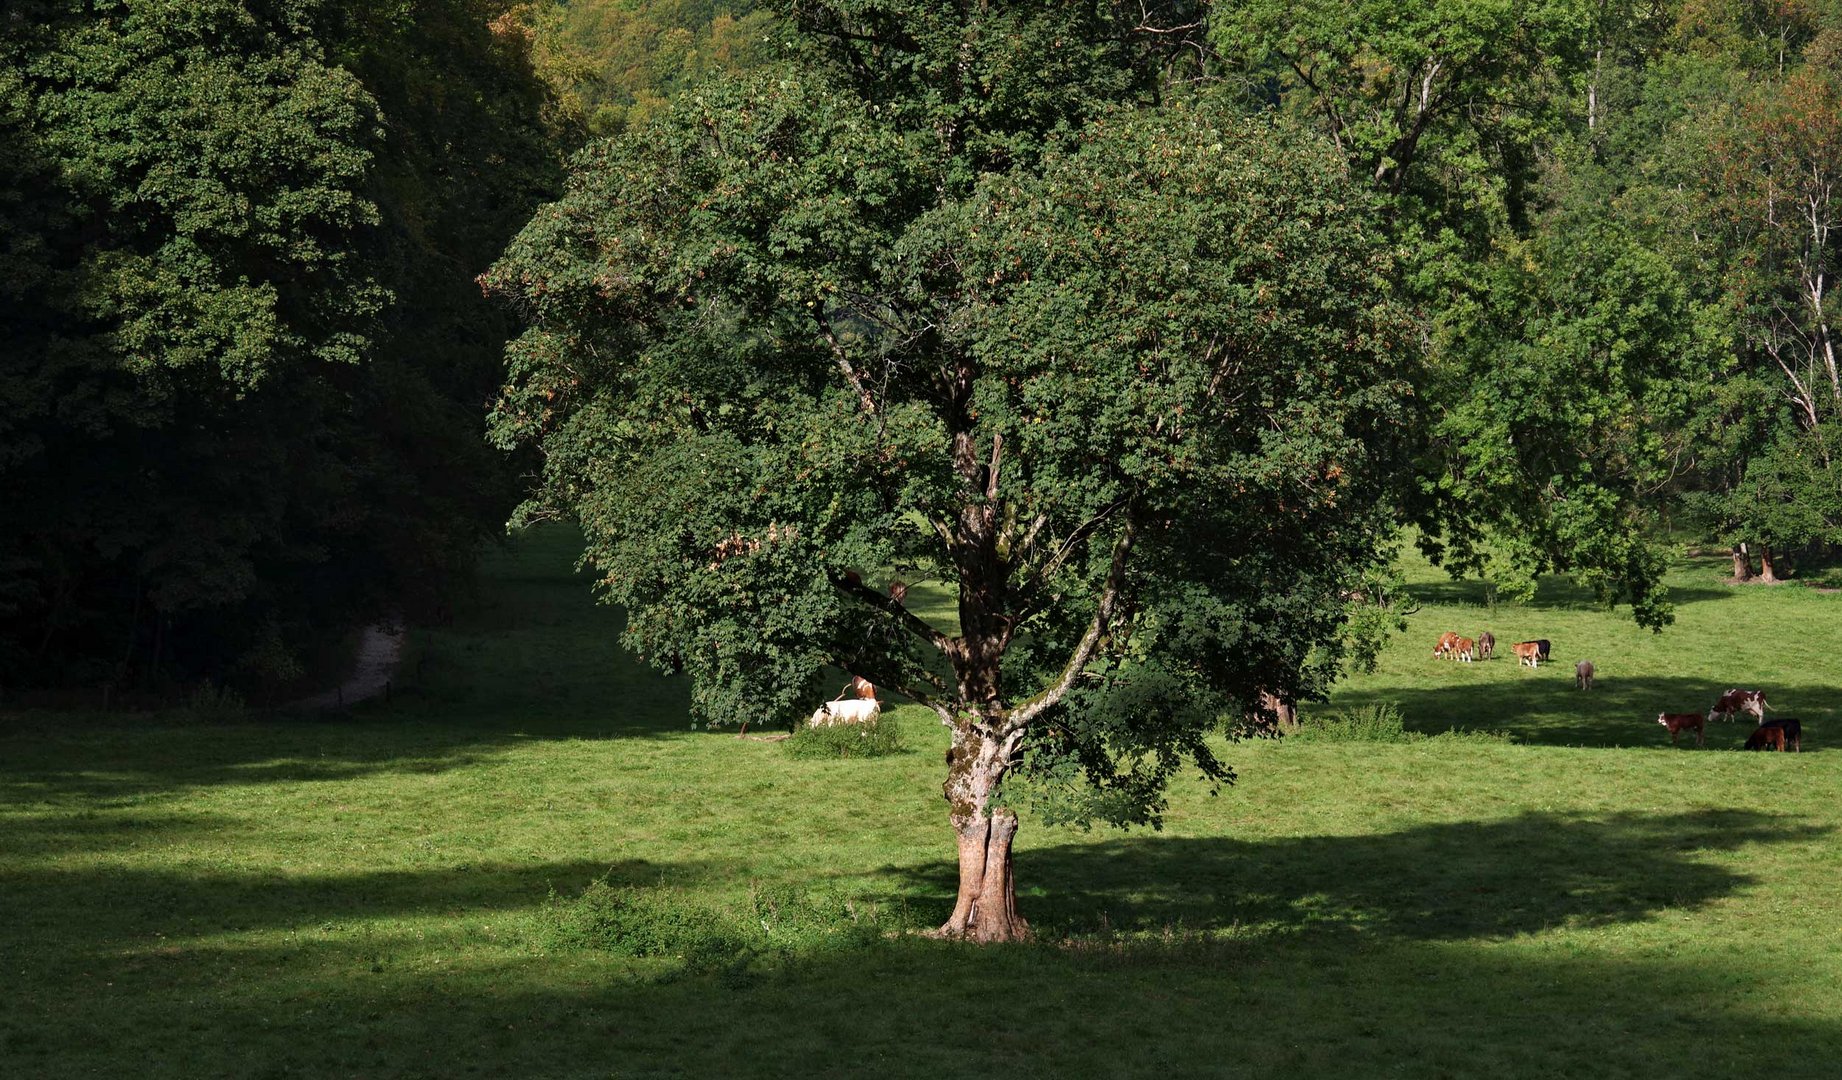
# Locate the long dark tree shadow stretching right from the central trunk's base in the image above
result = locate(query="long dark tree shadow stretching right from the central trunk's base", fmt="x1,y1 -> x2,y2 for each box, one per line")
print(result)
884,809 -> 1831,940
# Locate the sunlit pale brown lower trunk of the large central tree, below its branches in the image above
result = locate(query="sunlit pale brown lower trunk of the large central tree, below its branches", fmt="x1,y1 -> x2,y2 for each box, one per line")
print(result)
936,726 -> 1030,944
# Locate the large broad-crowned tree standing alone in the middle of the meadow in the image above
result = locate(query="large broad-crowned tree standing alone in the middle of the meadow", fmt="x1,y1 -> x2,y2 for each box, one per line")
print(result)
486,2 -> 1416,940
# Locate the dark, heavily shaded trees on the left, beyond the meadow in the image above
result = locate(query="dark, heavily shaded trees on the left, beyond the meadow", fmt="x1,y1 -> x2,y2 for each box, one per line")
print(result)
0,0 -> 556,691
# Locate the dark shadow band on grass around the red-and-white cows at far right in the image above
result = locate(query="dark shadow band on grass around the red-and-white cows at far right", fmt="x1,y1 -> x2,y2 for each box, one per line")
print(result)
1333,663 -> 1842,754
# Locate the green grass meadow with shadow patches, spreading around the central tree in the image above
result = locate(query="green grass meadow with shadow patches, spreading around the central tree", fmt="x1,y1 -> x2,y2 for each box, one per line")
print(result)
0,531 -> 1842,1080
